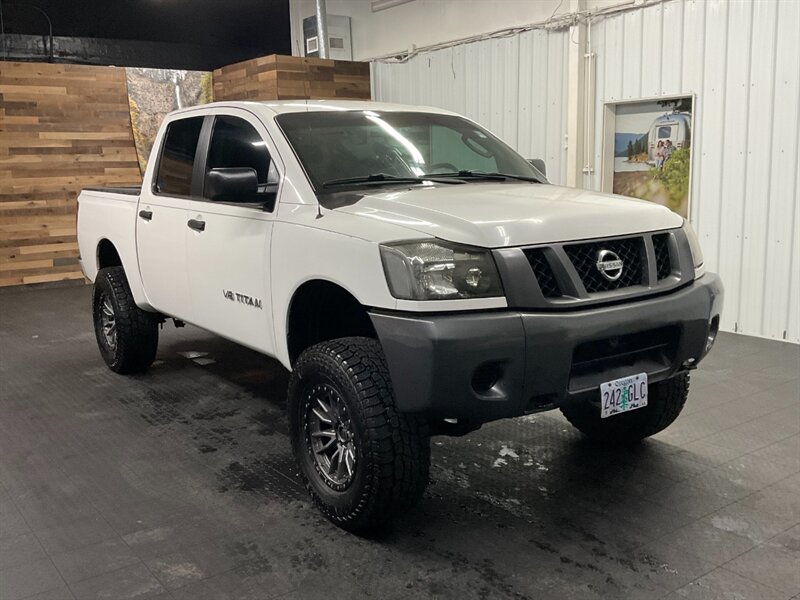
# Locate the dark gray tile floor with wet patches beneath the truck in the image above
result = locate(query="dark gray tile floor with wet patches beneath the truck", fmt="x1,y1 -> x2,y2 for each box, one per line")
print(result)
0,286 -> 800,600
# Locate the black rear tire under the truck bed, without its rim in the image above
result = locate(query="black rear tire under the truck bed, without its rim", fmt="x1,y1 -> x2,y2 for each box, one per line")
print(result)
92,267 -> 158,373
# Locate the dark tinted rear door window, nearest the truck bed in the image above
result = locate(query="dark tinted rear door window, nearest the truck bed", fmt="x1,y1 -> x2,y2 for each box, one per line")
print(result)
156,117 -> 203,196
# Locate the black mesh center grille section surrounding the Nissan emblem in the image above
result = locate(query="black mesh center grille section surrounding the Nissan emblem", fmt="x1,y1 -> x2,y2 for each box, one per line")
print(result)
564,237 -> 646,294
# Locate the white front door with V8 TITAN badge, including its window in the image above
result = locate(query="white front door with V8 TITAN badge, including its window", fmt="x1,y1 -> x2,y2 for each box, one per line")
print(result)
187,108 -> 283,354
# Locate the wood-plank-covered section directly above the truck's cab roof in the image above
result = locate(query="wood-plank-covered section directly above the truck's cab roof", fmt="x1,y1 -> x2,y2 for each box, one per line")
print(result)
214,54 -> 370,100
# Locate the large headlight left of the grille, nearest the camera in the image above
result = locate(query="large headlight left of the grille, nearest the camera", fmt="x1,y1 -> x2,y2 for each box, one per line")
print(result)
381,240 -> 503,300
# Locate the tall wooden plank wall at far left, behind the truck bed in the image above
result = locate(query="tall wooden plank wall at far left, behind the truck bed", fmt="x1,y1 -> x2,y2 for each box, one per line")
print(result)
0,61 -> 141,286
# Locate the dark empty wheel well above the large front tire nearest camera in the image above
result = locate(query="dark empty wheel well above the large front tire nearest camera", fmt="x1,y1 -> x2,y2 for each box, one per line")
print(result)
288,280 -> 377,364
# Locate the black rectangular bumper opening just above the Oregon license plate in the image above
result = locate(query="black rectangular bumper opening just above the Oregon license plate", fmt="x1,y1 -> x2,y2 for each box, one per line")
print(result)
569,326 -> 680,391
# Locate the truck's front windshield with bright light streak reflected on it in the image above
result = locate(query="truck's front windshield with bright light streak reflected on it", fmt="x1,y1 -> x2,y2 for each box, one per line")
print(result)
277,110 -> 541,192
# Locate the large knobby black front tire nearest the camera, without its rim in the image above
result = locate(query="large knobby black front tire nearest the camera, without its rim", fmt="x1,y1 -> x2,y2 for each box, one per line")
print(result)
288,337 -> 430,532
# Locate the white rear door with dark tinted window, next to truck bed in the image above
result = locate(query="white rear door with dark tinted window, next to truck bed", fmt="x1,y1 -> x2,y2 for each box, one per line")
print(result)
136,116 -> 205,321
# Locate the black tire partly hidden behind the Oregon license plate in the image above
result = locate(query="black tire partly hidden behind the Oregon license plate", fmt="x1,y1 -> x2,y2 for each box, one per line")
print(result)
561,373 -> 689,446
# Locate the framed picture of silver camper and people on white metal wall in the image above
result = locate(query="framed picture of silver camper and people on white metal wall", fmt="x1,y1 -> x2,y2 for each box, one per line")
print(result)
602,96 -> 694,219
